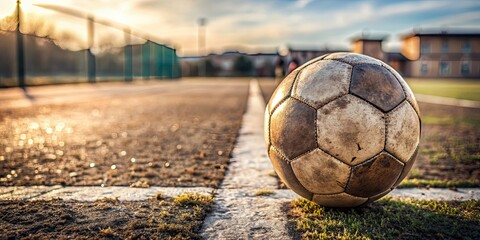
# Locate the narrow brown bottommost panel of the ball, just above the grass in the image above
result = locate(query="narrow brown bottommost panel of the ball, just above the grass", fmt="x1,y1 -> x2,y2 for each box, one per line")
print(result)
312,193 -> 368,207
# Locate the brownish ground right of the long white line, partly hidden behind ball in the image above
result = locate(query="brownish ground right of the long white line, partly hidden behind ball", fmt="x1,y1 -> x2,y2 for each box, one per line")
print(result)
260,80 -> 480,184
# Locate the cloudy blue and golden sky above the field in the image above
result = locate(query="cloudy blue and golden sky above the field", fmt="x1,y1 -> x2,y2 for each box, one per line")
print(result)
0,0 -> 480,55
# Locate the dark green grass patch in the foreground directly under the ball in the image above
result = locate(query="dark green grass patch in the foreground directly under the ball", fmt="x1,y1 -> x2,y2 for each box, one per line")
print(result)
288,198 -> 480,239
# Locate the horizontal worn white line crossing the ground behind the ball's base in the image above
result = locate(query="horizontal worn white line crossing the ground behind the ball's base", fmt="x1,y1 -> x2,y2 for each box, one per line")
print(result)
0,186 -> 480,202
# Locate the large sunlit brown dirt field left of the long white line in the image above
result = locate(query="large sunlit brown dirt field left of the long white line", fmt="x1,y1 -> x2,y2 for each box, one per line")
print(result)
0,80 -> 248,187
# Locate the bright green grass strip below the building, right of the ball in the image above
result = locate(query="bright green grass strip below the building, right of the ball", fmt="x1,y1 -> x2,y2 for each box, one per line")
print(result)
407,79 -> 480,101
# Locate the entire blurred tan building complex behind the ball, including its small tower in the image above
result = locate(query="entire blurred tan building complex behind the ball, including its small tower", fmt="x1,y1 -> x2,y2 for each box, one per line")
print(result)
352,29 -> 480,78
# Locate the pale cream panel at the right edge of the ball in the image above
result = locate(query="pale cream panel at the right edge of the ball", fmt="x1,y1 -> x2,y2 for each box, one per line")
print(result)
385,101 -> 420,162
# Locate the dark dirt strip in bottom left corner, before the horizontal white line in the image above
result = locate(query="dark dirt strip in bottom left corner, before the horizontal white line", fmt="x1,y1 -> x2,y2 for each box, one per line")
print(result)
0,194 -> 213,239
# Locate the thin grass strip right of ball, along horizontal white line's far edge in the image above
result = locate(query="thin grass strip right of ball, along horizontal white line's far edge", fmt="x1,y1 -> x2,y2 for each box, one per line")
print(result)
398,178 -> 480,188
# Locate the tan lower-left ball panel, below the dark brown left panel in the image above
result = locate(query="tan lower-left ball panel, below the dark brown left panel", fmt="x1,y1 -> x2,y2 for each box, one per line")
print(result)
291,148 -> 350,194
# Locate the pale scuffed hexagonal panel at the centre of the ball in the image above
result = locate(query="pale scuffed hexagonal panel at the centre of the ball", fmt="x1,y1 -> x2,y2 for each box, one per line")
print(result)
317,95 -> 385,166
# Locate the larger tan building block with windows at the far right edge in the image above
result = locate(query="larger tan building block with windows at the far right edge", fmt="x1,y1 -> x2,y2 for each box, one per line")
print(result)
401,29 -> 480,78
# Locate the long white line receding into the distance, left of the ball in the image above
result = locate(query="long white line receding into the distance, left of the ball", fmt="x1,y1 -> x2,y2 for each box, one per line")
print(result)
200,80 -> 290,239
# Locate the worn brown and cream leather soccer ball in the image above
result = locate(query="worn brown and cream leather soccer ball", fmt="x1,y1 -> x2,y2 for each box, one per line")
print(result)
265,53 -> 420,207
